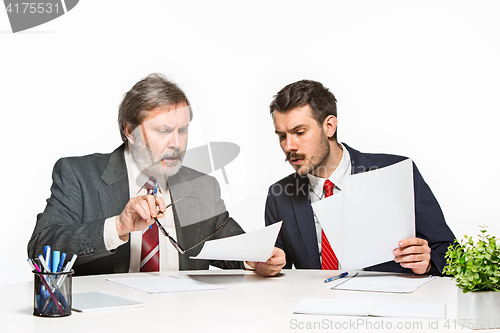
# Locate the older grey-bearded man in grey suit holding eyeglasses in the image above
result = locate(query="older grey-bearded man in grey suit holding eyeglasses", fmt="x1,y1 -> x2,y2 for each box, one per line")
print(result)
28,74 -> 284,275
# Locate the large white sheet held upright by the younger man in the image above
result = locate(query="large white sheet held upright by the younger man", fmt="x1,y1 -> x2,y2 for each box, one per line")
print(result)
312,159 -> 415,270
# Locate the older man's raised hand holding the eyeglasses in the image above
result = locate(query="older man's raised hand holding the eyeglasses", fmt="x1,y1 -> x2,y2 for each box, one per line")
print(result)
115,195 -> 165,241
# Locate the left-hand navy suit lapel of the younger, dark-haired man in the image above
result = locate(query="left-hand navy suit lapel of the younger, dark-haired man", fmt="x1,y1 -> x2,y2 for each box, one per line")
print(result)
290,174 -> 320,267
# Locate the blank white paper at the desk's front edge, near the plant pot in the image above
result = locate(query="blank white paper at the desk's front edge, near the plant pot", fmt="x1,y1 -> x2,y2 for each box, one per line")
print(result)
293,298 -> 446,318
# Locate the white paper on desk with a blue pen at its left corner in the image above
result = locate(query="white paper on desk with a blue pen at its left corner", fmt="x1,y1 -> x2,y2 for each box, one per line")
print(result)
326,272 -> 435,294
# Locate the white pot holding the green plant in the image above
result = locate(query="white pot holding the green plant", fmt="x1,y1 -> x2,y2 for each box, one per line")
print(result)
457,289 -> 500,329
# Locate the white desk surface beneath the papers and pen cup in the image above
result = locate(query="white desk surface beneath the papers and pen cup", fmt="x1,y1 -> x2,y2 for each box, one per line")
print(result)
0,270 -> 480,333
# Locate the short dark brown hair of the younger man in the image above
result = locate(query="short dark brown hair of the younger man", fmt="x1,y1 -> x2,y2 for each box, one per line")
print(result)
269,80 -> 337,140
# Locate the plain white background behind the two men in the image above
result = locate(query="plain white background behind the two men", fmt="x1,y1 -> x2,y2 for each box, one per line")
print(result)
0,0 -> 500,284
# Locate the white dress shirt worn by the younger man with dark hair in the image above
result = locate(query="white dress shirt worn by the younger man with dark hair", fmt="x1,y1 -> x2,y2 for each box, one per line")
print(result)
307,144 -> 351,269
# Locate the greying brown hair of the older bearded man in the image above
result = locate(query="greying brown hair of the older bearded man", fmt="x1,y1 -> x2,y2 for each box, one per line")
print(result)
118,73 -> 193,142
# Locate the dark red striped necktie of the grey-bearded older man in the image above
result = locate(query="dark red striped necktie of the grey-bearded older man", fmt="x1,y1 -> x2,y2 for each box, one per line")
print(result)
140,178 -> 160,272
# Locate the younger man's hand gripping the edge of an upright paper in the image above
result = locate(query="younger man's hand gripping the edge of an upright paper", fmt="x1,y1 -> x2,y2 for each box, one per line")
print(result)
394,237 -> 431,274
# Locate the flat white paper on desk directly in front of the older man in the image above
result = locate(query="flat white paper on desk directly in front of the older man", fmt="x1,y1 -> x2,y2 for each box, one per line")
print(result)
106,276 -> 224,294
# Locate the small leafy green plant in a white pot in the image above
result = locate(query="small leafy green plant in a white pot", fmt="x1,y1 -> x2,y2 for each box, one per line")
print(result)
443,225 -> 500,329
